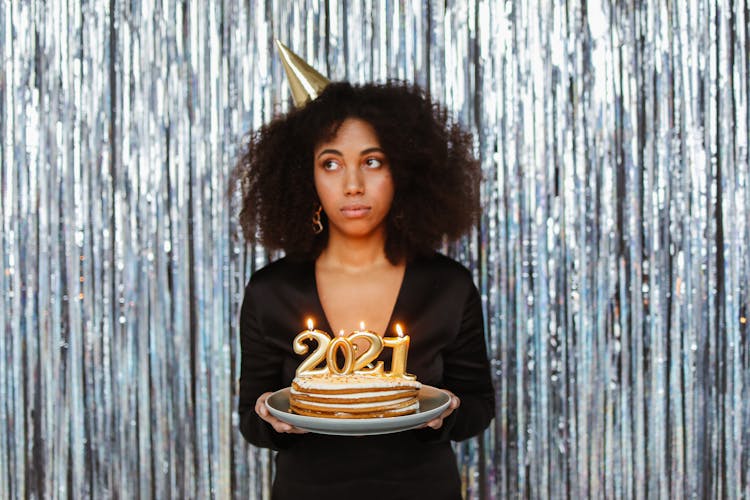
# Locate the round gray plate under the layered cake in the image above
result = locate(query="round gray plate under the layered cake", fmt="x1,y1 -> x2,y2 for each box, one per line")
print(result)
266,385 -> 450,436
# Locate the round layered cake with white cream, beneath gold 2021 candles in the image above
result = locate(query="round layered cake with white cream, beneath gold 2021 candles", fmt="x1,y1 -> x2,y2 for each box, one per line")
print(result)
289,373 -> 420,418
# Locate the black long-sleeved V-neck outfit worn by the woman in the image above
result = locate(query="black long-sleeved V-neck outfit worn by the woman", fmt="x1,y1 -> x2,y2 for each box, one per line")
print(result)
238,253 -> 495,500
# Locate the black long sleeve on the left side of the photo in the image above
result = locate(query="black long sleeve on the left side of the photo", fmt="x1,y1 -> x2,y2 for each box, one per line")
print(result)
238,280 -> 297,450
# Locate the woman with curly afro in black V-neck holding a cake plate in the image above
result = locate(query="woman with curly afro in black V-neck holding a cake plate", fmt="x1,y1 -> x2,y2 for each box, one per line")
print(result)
235,83 -> 494,499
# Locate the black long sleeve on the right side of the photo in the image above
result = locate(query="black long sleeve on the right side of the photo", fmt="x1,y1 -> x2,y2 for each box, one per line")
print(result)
419,284 -> 495,441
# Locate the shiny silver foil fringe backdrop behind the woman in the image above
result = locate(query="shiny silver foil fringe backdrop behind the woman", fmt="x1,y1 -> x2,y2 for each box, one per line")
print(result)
0,0 -> 750,499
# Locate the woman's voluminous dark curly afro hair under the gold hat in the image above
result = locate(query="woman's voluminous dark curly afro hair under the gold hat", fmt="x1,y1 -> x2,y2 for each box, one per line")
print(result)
232,82 -> 481,263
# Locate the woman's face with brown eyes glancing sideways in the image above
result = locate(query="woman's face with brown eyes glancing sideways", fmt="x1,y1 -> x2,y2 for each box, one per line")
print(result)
313,118 -> 393,242
